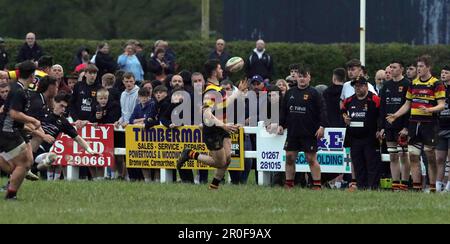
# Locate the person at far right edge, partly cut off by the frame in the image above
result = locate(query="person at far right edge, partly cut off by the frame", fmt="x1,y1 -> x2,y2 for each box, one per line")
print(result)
436,65 -> 450,192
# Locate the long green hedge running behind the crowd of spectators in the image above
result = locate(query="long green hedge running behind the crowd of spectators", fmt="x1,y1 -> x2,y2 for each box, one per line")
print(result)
6,39 -> 450,84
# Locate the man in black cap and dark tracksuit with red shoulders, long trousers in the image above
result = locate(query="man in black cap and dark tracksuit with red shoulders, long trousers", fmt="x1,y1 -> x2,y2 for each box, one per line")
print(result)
342,77 -> 380,189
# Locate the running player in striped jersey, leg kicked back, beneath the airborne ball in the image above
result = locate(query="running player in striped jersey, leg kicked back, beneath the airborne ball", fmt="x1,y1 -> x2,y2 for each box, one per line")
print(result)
177,60 -> 248,190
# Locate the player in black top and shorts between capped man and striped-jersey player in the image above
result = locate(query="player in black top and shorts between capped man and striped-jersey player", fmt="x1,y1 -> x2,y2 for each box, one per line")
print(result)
379,60 -> 410,191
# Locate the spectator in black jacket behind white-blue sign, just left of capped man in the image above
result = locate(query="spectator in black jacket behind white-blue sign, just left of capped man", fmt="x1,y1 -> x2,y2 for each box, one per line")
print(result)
323,68 -> 346,128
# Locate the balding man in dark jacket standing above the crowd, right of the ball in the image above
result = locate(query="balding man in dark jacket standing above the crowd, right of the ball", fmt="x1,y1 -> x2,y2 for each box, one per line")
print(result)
246,40 -> 273,81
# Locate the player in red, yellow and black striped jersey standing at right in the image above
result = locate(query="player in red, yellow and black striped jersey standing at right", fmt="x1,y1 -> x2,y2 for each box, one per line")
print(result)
387,55 -> 446,192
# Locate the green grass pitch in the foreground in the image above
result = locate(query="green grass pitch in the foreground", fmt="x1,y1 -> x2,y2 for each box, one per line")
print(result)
0,179 -> 450,224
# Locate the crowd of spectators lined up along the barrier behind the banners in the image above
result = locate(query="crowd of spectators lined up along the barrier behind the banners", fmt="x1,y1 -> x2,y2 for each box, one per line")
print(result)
0,33 -> 450,192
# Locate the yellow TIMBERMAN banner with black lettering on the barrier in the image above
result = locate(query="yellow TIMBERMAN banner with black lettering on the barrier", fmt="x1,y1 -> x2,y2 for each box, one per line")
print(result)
126,126 -> 244,171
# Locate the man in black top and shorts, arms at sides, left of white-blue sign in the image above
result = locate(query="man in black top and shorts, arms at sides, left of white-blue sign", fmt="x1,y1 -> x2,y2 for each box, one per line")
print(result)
278,65 -> 328,190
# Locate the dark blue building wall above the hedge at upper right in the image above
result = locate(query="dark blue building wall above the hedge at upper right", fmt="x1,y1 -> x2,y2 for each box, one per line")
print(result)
224,0 -> 450,44
